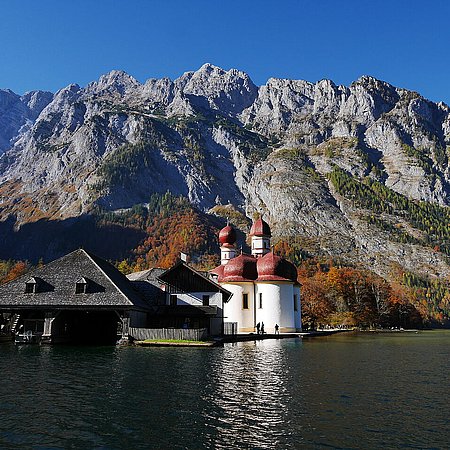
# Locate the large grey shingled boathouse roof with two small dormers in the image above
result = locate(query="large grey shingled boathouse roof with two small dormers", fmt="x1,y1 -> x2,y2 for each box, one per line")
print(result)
0,249 -> 149,310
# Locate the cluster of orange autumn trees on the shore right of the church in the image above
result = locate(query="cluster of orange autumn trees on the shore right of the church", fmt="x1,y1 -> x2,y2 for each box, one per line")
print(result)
298,260 -> 426,328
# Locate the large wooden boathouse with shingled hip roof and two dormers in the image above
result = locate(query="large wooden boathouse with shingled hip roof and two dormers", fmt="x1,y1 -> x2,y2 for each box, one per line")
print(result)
0,249 -> 150,344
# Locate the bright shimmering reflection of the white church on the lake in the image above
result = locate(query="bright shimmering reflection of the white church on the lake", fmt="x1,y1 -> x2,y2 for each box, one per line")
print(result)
204,340 -> 302,448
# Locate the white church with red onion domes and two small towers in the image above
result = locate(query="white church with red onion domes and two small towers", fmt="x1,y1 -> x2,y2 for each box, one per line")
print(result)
211,218 -> 301,333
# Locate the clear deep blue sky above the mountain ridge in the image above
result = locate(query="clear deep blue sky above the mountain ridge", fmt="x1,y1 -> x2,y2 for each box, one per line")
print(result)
0,0 -> 450,104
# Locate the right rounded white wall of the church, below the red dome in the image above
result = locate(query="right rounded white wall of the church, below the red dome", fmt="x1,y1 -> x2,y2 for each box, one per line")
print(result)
256,281 -> 296,333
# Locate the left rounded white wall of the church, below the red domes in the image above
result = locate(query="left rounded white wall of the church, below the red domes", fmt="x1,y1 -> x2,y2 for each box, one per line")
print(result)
222,282 -> 255,333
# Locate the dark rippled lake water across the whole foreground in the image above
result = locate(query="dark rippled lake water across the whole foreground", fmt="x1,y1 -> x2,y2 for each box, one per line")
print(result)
0,331 -> 450,449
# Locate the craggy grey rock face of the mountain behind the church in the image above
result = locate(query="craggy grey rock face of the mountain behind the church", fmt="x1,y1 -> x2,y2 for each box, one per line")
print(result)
0,64 -> 450,275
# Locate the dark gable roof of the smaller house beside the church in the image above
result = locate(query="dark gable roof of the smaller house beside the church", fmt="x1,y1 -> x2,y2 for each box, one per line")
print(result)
158,261 -> 232,302
